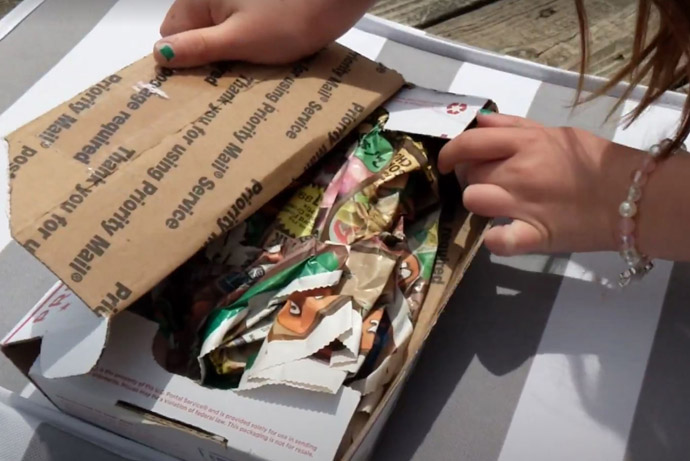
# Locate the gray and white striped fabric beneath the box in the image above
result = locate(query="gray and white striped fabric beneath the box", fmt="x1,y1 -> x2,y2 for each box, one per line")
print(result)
0,0 -> 690,461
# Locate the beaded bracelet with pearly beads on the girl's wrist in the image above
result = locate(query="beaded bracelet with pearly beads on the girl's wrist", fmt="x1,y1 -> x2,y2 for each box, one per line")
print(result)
618,139 -> 685,287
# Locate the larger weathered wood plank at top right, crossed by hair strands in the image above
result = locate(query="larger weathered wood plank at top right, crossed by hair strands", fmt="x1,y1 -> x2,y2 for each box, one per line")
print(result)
429,0 -> 637,76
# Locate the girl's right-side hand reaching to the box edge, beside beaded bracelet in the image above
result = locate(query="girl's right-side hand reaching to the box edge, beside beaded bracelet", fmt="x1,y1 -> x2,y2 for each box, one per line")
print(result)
439,114 -> 645,256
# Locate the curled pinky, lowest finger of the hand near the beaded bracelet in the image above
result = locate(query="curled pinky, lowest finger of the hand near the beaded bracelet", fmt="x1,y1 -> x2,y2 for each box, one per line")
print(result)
484,220 -> 546,256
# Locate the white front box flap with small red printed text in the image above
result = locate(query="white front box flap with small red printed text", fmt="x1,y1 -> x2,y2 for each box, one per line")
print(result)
30,312 -> 360,461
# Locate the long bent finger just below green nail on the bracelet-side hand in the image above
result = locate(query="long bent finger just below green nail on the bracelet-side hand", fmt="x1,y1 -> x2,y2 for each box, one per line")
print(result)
438,126 -> 530,174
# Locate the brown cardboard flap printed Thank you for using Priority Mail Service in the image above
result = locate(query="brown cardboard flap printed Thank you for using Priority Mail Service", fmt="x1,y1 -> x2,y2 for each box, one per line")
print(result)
8,45 -> 403,317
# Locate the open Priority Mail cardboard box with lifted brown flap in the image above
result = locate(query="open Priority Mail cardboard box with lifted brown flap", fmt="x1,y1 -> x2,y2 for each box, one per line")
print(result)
3,45 -> 493,460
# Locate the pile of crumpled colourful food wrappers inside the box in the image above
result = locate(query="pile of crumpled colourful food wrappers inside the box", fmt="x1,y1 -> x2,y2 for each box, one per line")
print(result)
132,110 -> 446,411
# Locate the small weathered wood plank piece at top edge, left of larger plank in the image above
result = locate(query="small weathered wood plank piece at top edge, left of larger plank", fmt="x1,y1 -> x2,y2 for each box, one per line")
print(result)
368,0 -> 499,28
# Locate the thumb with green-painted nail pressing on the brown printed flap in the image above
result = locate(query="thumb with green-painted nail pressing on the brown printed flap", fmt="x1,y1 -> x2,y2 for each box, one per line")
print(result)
154,17 -> 241,68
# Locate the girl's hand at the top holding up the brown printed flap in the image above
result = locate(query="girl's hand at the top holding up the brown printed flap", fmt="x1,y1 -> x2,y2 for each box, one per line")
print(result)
154,0 -> 374,68
